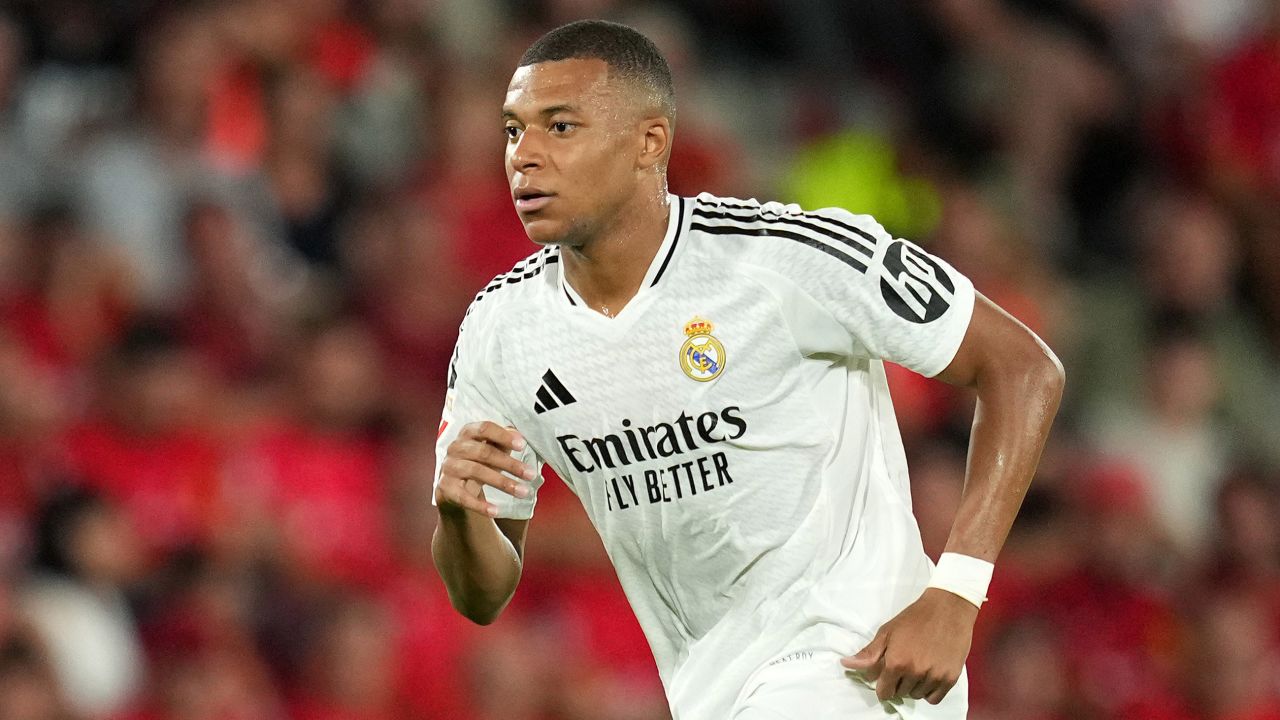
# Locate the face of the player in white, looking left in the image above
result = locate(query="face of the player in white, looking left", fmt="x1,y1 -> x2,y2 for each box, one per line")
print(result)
503,59 -> 644,246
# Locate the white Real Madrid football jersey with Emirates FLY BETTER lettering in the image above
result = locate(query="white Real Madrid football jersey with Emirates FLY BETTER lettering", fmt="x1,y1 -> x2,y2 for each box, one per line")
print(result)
436,193 -> 974,720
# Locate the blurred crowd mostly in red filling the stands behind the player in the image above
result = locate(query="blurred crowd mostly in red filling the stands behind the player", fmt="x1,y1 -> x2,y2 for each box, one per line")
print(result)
0,0 -> 1280,720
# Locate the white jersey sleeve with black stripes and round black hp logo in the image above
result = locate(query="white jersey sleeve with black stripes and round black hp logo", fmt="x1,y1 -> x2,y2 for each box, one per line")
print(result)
757,199 -> 974,377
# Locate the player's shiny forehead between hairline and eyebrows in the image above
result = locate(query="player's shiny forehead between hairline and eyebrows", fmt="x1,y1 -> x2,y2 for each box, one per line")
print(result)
503,58 -> 616,114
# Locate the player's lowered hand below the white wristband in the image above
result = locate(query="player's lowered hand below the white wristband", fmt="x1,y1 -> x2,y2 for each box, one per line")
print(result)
840,588 -> 978,705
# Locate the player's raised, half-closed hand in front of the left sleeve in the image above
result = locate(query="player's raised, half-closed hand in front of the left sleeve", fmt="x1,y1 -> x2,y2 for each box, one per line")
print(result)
435,421 -> 536,518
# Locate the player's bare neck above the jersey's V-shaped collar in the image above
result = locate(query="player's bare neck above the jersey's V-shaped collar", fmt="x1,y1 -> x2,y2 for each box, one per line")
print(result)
561,185 -> 671,316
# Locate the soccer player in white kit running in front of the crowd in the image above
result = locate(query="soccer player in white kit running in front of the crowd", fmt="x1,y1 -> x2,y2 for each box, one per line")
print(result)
433,20 -> 1062,720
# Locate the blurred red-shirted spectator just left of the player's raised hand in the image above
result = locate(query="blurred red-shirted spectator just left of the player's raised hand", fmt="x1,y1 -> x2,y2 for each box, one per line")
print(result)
230,320 -> 390,585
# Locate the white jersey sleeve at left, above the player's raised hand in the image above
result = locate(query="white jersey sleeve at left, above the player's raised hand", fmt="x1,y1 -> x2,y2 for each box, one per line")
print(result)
431,308 -> 543,520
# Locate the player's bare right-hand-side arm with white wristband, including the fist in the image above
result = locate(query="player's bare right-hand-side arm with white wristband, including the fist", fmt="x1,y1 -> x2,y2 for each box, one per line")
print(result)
842,289 -> 1064,703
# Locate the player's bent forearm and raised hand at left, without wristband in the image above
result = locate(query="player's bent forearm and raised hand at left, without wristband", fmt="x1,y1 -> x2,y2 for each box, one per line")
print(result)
431,423 -> 534,625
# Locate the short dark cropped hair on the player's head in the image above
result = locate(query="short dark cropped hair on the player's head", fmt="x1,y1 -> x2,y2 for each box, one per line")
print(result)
518,20 -> 676,119
